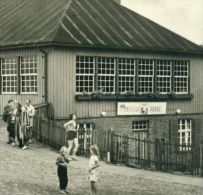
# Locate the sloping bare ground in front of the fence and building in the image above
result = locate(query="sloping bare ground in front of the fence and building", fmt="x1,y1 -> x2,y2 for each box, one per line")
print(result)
0,119 -> 203,195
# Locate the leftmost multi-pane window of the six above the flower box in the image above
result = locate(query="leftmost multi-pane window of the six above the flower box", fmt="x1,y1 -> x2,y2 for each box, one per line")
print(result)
76,56 -> 95,93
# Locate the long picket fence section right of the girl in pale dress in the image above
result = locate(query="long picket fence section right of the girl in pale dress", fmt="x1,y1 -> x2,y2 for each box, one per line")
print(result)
97,131 -> 203,176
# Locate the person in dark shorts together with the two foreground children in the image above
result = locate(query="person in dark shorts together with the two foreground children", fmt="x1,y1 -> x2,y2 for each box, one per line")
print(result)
56,114 -> 99,194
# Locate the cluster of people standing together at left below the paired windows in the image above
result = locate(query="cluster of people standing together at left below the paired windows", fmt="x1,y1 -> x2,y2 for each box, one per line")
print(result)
2,99 -> 35,150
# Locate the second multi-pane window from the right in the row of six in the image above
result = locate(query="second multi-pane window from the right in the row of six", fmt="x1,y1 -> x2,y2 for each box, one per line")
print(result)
156,60 -> 172,94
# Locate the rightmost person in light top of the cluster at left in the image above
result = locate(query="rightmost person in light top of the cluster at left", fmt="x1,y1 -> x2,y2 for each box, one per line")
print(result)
25,99 -> 35,143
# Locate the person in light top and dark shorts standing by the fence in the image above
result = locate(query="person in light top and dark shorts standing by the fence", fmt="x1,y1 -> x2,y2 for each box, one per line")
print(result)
64,114 -> 79,160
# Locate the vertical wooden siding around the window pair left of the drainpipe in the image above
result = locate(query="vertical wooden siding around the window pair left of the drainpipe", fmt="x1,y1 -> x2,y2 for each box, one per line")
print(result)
0,49 -> 44,114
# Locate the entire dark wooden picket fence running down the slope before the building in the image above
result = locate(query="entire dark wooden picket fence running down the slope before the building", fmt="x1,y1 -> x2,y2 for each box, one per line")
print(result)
32,118 -> 203,176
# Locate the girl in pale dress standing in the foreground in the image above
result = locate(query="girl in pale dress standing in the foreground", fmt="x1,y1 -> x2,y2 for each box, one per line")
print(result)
88,145 -> 99,194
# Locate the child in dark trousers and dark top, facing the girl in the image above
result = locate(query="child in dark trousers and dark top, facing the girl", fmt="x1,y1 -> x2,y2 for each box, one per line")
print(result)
56,146 -> 69,194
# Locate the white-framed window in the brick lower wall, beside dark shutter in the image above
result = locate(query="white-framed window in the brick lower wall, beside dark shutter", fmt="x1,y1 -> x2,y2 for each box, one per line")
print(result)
178,119 -> 192,150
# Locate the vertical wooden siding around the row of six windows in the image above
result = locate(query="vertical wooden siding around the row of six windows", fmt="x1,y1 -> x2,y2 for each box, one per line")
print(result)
48,49 -> 203,118
